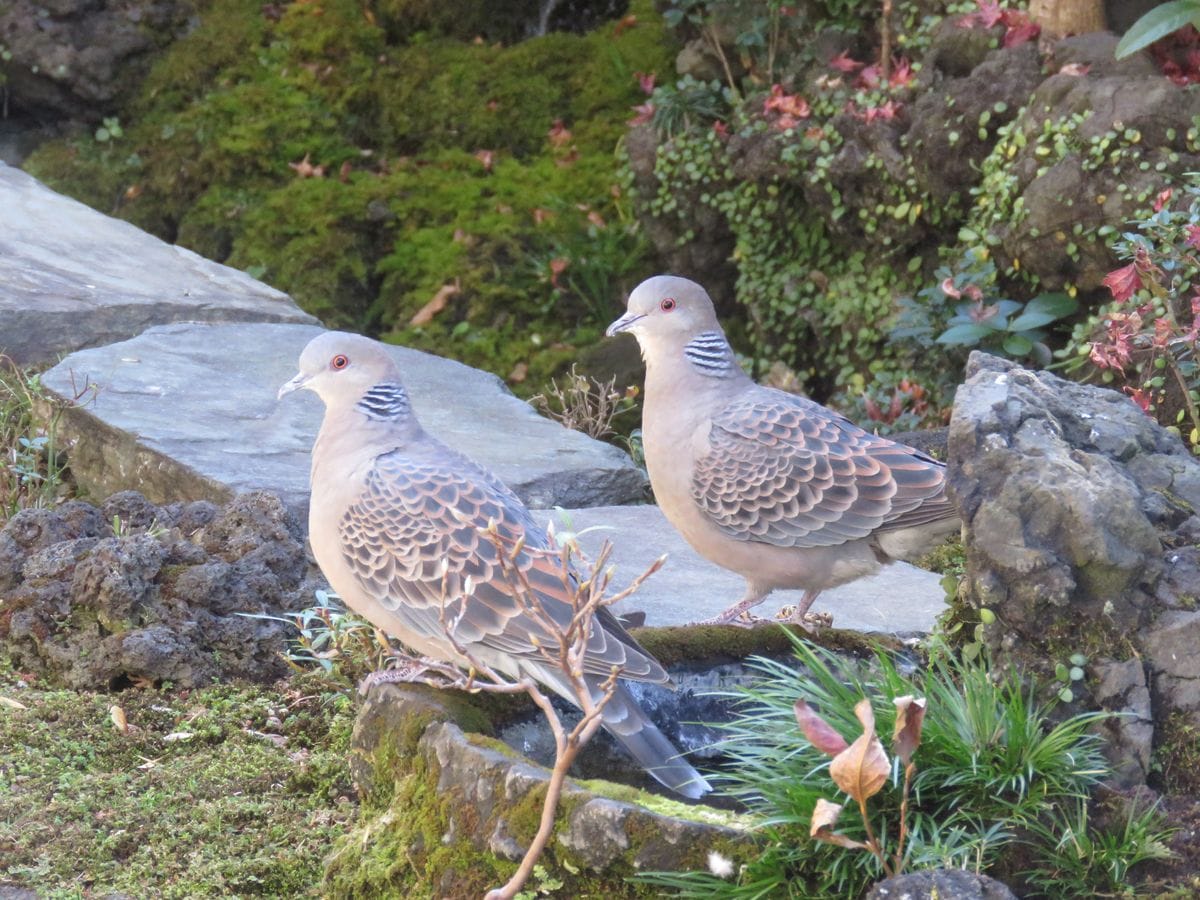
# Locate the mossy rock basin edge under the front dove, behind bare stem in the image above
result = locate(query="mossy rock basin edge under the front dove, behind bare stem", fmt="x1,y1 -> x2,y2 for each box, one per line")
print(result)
324,684 -> 754,898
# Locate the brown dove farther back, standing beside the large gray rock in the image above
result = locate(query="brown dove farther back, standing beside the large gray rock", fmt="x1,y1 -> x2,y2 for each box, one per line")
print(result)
607,275 -> 959,624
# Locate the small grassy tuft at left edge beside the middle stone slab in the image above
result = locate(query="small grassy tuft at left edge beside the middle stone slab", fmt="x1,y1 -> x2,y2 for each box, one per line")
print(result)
0,355 -> 78,526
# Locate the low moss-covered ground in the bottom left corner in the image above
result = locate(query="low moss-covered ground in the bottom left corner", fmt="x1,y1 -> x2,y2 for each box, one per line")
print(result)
0,668 -> 356,898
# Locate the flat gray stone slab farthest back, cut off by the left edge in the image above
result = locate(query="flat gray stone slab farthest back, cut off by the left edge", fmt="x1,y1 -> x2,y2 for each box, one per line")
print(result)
0,163 -> 317,366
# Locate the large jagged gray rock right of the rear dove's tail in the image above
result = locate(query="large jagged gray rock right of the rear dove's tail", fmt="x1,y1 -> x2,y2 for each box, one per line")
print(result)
949,353 -> 1200,785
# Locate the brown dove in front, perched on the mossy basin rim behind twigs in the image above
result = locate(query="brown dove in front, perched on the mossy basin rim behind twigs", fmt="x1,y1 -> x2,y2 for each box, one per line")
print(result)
280,331 -> 710,798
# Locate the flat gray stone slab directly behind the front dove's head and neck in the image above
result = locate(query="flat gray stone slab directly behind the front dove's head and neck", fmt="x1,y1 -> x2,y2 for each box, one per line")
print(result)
43,324 -> 646,512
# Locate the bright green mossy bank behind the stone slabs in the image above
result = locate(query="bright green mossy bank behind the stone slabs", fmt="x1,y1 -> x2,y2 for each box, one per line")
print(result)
21,0 -> 672,391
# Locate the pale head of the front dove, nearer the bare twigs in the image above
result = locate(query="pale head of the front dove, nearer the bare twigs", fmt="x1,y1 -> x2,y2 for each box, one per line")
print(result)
280,331 -> 402,407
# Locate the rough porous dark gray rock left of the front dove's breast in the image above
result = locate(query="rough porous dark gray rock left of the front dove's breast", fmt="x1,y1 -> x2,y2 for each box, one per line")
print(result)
0,493 -> 313,689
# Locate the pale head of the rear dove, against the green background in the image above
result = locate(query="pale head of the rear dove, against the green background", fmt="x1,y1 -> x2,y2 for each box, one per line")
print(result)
605,275 -> 720,352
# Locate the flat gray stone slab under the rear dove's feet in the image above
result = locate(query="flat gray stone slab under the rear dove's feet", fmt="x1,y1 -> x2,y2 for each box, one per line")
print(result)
536,504 -> 946,635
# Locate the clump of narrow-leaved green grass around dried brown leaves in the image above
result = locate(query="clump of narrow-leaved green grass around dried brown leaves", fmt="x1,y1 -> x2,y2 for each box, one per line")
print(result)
643,637 -> 1162,900
